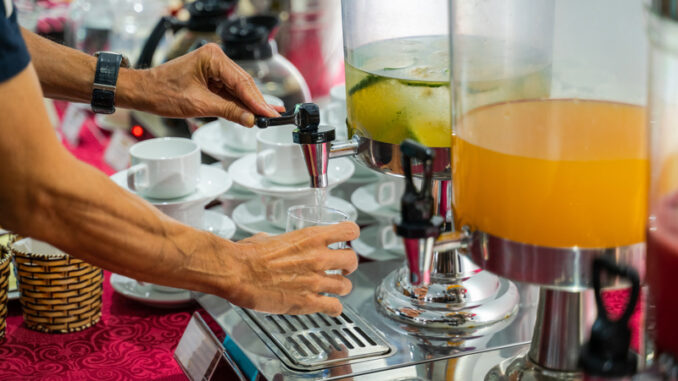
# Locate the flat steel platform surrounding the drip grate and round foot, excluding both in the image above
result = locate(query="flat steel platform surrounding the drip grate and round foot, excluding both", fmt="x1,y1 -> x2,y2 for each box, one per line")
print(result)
197,261 -> 536,381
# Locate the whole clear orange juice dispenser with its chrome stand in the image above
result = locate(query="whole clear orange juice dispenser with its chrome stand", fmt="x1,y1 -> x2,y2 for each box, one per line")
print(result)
450,0 -> 648,379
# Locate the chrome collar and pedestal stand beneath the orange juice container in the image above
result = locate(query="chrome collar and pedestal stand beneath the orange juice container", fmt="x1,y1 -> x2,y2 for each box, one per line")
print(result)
464,232 -> 645,381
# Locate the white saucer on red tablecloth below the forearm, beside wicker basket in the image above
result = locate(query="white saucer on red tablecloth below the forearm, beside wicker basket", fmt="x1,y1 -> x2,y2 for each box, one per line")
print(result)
111,274 -> 193,308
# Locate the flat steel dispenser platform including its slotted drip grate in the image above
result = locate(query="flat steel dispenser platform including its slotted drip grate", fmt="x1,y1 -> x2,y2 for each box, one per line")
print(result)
196,260 -> 537,381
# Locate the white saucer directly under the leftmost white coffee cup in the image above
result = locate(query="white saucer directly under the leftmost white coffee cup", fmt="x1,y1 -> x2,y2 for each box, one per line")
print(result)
111,164 -> 233,205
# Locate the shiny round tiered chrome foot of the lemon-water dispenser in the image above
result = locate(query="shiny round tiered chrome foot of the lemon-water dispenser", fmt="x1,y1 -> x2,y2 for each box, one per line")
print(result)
375,260 -> 519,330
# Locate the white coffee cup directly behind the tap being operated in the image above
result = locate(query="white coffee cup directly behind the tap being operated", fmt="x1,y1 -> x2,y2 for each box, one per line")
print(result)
256,125 -> 310,185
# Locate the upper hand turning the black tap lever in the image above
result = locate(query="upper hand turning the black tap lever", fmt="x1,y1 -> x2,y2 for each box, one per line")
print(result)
132,44 -> 284,127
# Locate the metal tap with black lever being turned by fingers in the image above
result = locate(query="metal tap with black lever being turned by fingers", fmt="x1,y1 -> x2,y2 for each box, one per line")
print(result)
256,103 -> 359,188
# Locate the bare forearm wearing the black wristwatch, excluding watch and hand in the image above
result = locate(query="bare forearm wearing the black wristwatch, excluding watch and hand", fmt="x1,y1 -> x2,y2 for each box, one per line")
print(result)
21,28 -> 145,108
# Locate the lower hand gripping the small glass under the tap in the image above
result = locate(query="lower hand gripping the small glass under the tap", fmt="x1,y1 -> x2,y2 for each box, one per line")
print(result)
220,222 -> 360,316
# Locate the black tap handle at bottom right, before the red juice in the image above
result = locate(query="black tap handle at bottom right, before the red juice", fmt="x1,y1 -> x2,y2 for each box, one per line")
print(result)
579,257 -> 640,377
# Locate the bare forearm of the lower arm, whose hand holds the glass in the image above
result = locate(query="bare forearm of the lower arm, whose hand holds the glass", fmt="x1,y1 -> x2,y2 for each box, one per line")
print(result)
24,157 -> 235,292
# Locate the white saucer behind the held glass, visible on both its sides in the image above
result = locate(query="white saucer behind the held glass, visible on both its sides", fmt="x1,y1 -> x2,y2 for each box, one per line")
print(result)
232,196 -> 358,235
